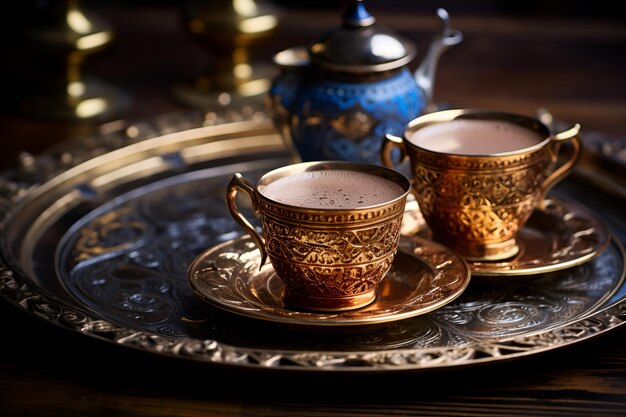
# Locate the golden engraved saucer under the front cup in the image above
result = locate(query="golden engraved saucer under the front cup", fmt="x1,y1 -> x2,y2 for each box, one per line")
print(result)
188,236 -> 471,326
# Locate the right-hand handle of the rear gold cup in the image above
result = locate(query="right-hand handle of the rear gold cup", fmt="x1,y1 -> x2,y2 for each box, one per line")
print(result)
537,123 -> 581,210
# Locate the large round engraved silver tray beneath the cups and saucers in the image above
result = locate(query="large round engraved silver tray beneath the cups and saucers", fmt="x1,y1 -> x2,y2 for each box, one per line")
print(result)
0,113 -> 626,372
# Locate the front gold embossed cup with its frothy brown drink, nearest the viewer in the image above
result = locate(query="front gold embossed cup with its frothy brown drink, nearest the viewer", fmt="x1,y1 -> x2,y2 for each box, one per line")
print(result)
226,161 -> 411,311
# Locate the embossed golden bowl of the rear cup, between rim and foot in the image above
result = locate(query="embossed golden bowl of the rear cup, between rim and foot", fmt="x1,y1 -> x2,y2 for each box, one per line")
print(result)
413,152 -> 545,244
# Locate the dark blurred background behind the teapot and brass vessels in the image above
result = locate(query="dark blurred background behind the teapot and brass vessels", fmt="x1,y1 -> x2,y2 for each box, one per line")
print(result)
0,0 -> 626,166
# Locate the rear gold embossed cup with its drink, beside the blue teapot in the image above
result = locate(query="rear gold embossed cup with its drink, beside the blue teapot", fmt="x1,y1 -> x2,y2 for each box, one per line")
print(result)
381,109 -> 580,261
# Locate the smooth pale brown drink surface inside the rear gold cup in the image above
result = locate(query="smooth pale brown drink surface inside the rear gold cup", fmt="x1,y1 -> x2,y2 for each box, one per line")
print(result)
407,119 -> 544,155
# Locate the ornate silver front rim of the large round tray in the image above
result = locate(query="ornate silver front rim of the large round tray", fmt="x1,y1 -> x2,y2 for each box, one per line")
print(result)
0,254 -> 626,372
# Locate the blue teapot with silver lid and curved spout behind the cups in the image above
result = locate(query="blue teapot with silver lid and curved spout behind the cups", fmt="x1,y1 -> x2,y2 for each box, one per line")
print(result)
268,1 -> 463,164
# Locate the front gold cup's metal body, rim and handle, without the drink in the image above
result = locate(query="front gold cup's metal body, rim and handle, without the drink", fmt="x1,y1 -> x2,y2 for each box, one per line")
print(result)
227,161 -> 410,311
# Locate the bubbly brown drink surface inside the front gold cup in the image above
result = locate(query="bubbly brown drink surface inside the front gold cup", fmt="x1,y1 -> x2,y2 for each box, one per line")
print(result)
259,169 -> 404,209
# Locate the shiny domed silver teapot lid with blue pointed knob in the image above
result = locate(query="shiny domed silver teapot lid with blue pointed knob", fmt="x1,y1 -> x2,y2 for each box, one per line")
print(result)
309,0 -> 416,74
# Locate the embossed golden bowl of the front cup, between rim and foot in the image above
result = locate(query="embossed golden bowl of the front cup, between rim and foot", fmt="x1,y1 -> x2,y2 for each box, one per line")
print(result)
263,205 -> 404,305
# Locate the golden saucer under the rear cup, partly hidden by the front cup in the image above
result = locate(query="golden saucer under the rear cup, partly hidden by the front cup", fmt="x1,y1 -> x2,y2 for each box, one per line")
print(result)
401,196 -> 611,276
